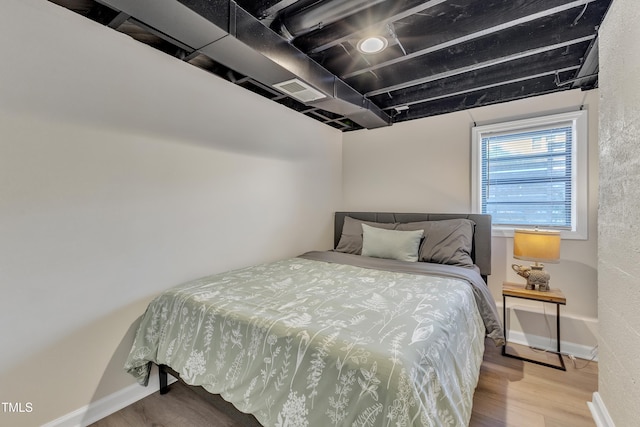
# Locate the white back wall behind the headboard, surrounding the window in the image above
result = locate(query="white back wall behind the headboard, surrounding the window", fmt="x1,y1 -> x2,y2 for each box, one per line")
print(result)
343,90 -> 598,356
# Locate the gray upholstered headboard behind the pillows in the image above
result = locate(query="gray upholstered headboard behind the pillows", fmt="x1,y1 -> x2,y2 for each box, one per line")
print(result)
333,212 -> 491,280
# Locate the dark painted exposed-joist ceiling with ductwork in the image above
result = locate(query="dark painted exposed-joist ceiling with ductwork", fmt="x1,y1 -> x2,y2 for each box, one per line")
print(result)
50,0 -> 612,131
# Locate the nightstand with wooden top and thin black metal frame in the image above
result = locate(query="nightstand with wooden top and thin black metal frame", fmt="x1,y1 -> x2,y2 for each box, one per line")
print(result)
502,282 -> 567,371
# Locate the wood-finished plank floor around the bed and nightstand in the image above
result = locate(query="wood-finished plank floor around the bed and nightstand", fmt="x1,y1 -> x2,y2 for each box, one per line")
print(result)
92,341 -> 598,427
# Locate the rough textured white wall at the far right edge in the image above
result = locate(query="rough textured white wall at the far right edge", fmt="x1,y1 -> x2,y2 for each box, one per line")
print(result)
594,0 -> 640,427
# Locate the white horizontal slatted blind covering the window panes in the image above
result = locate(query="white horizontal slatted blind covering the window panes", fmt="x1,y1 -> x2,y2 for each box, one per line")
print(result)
481,123 -> 573,230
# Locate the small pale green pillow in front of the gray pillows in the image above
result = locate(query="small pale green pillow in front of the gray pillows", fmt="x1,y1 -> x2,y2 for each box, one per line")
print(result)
362,224 -> 424,262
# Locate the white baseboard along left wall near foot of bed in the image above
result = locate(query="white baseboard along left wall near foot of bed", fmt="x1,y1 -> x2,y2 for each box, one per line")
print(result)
42,372 -> 176,427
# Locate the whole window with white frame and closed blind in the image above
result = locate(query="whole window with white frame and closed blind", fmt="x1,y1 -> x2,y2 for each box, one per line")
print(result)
472,111 -> 587,239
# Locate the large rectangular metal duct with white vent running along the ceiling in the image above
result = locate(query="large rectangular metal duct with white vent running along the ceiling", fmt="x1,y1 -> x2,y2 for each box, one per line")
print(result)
98,0 -> 391,129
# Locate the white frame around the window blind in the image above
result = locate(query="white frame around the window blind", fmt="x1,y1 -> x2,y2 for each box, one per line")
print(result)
471,110 -> 589,240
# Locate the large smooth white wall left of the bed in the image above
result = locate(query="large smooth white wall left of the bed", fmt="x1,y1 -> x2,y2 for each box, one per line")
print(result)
0,0 -> 342,426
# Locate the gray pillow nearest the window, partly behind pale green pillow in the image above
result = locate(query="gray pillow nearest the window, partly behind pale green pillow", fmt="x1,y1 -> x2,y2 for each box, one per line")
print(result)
396,218 -> 476,267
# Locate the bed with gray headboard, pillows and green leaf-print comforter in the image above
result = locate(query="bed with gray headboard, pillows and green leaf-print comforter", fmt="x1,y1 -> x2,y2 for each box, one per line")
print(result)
125,212 -> 504,427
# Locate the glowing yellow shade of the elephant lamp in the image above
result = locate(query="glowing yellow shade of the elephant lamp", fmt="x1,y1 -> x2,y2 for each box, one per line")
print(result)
513,230 -> 560,263
